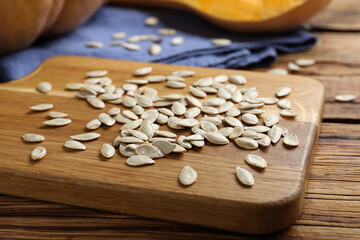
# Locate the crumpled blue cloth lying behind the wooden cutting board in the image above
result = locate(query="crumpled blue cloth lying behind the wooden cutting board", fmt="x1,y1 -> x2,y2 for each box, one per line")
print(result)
0,6 -> 316,82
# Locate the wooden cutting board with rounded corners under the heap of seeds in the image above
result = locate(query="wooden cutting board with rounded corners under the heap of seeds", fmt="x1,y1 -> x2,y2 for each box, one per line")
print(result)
0,56 -> 324,234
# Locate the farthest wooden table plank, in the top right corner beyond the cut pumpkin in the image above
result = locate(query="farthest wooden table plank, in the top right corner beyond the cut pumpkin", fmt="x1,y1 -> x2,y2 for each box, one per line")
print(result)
309,0 -> 360,31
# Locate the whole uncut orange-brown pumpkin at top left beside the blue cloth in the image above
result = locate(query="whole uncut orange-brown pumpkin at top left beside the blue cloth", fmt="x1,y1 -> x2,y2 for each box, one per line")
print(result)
0,0 -> 104,55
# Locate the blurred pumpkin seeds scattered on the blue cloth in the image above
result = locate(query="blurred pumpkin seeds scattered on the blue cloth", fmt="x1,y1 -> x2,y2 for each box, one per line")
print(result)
85,16 -> 232,56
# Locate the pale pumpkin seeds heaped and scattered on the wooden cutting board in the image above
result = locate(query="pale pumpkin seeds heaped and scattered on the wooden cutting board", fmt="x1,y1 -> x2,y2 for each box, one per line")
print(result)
26,67 -> 299,186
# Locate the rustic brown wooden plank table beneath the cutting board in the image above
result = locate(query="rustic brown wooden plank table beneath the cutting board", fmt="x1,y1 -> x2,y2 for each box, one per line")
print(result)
0,0 -> 360,240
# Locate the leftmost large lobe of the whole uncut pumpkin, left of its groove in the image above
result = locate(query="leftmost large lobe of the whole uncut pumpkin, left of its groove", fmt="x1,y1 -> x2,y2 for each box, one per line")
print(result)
0,0 -> 53,55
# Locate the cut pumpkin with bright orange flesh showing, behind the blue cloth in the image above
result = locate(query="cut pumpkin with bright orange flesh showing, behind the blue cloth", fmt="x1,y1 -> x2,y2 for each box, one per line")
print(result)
109,0 -> 330,33
